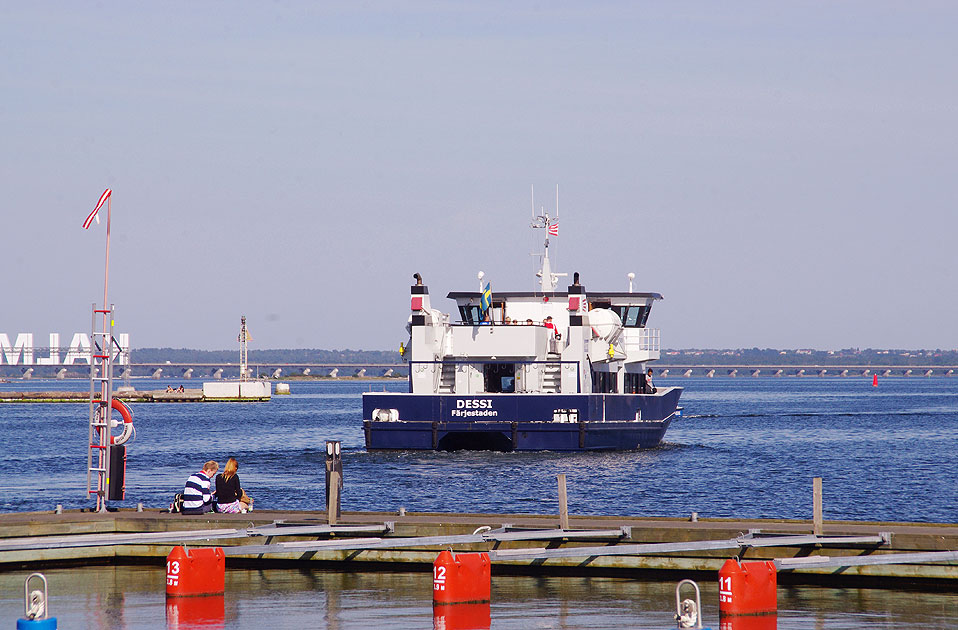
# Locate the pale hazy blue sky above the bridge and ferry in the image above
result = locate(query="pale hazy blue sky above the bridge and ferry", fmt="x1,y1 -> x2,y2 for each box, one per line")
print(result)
0,2 -> 958,349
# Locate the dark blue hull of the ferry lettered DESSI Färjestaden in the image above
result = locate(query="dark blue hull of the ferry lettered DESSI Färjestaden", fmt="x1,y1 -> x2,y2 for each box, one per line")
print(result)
363,387 -> 682,451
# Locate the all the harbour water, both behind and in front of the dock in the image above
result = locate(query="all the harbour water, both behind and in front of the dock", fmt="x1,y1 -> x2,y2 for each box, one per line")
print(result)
0,378 -> 958,630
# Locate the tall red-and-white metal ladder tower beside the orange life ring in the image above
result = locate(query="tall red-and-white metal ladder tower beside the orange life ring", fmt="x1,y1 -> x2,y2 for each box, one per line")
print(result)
86,304 -> 116,512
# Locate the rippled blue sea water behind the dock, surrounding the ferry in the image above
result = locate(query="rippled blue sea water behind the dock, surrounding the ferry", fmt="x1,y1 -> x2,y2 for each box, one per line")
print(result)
0,377 -> 958,522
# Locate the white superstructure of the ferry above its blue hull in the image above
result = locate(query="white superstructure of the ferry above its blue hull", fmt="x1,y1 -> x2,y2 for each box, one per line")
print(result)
405,215 -> 662,395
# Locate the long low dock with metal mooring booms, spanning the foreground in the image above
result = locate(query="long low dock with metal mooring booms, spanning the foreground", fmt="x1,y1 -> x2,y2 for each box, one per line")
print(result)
0,510 -> 958,591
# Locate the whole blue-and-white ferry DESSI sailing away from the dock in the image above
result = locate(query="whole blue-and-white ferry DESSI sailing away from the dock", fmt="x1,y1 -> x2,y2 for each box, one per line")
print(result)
363,212 -> 682,451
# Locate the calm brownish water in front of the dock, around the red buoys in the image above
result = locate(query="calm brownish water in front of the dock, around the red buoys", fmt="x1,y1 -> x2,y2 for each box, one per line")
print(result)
0,567 -> 958,630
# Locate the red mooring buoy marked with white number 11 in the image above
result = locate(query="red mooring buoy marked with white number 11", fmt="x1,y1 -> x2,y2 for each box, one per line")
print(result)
719,559 -> 778,617
